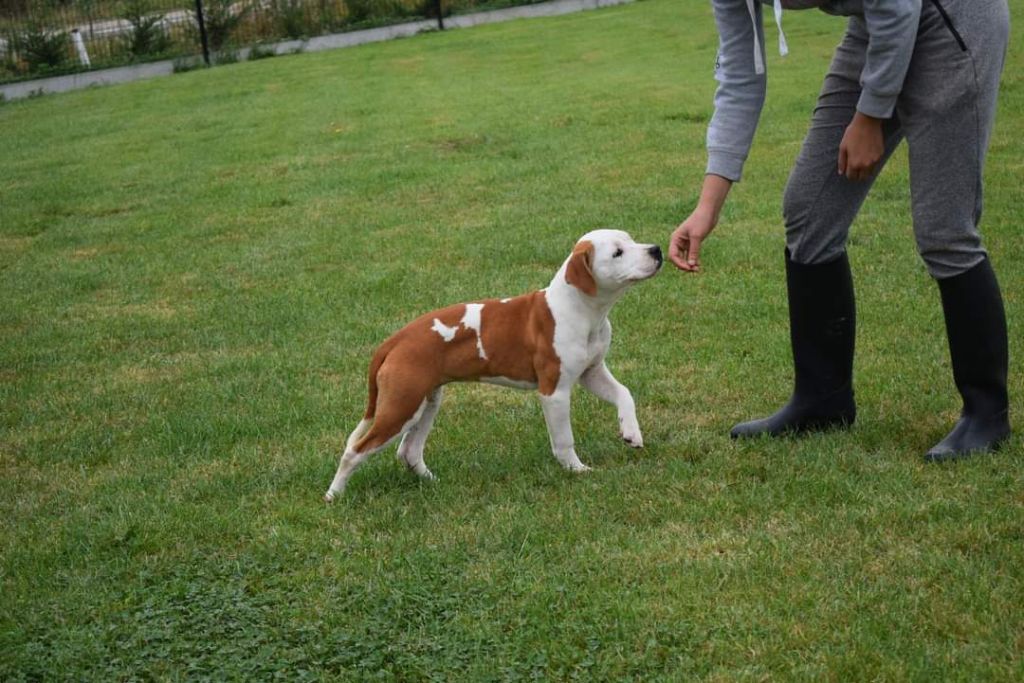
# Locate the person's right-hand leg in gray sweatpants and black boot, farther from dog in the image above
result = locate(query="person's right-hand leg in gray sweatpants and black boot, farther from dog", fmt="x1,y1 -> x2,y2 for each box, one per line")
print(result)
897,0 -> 1010,461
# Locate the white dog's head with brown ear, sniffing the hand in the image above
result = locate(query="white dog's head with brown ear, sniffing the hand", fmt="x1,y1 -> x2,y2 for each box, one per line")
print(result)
565,229 -> 664,296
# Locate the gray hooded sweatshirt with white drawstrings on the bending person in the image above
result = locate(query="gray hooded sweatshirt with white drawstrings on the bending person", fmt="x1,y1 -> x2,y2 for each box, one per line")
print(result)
707,0 -> 922,181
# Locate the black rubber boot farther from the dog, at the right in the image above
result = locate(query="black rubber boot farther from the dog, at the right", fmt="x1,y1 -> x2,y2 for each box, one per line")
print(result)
925,258 -> 1010,462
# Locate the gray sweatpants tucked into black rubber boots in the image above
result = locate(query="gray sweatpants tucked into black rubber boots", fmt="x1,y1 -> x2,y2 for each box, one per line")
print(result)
782,0 -> 1010,279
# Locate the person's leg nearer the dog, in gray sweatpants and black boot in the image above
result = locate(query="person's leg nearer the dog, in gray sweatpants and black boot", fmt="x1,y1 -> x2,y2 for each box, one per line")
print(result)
730,19 -> 902,438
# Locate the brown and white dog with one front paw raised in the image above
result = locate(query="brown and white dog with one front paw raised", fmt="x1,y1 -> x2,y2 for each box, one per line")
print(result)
324,229 -> 662,502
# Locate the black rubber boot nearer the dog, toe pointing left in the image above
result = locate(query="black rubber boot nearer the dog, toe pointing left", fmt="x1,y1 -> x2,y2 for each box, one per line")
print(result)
729,250 -> 857,438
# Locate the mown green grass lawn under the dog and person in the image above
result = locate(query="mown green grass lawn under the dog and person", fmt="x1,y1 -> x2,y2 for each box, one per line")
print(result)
0,0 -> 1024,681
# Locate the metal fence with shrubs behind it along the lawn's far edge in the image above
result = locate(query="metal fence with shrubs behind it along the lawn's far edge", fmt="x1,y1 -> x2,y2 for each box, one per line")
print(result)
0,0 -> 544,83
